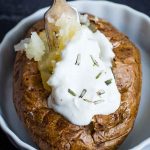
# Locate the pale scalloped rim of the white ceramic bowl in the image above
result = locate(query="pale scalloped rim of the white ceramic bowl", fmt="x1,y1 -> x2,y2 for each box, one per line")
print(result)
0,0 -> 150,150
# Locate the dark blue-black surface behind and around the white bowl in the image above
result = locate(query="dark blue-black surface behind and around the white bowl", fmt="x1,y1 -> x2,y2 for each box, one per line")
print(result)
0,0 -> 150,150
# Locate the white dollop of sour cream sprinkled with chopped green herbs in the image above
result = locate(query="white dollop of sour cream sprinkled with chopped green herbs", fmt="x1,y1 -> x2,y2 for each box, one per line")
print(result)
47,25 -> 121,125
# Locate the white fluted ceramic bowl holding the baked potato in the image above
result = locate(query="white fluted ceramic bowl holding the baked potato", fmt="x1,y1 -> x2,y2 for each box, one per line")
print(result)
0,1 -> 150,150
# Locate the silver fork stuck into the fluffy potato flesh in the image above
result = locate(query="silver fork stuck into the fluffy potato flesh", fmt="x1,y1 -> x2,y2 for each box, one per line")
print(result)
45,0 -> 78,50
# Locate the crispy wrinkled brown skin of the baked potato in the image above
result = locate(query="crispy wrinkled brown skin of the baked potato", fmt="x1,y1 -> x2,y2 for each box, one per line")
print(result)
13,15 -> 142,150
